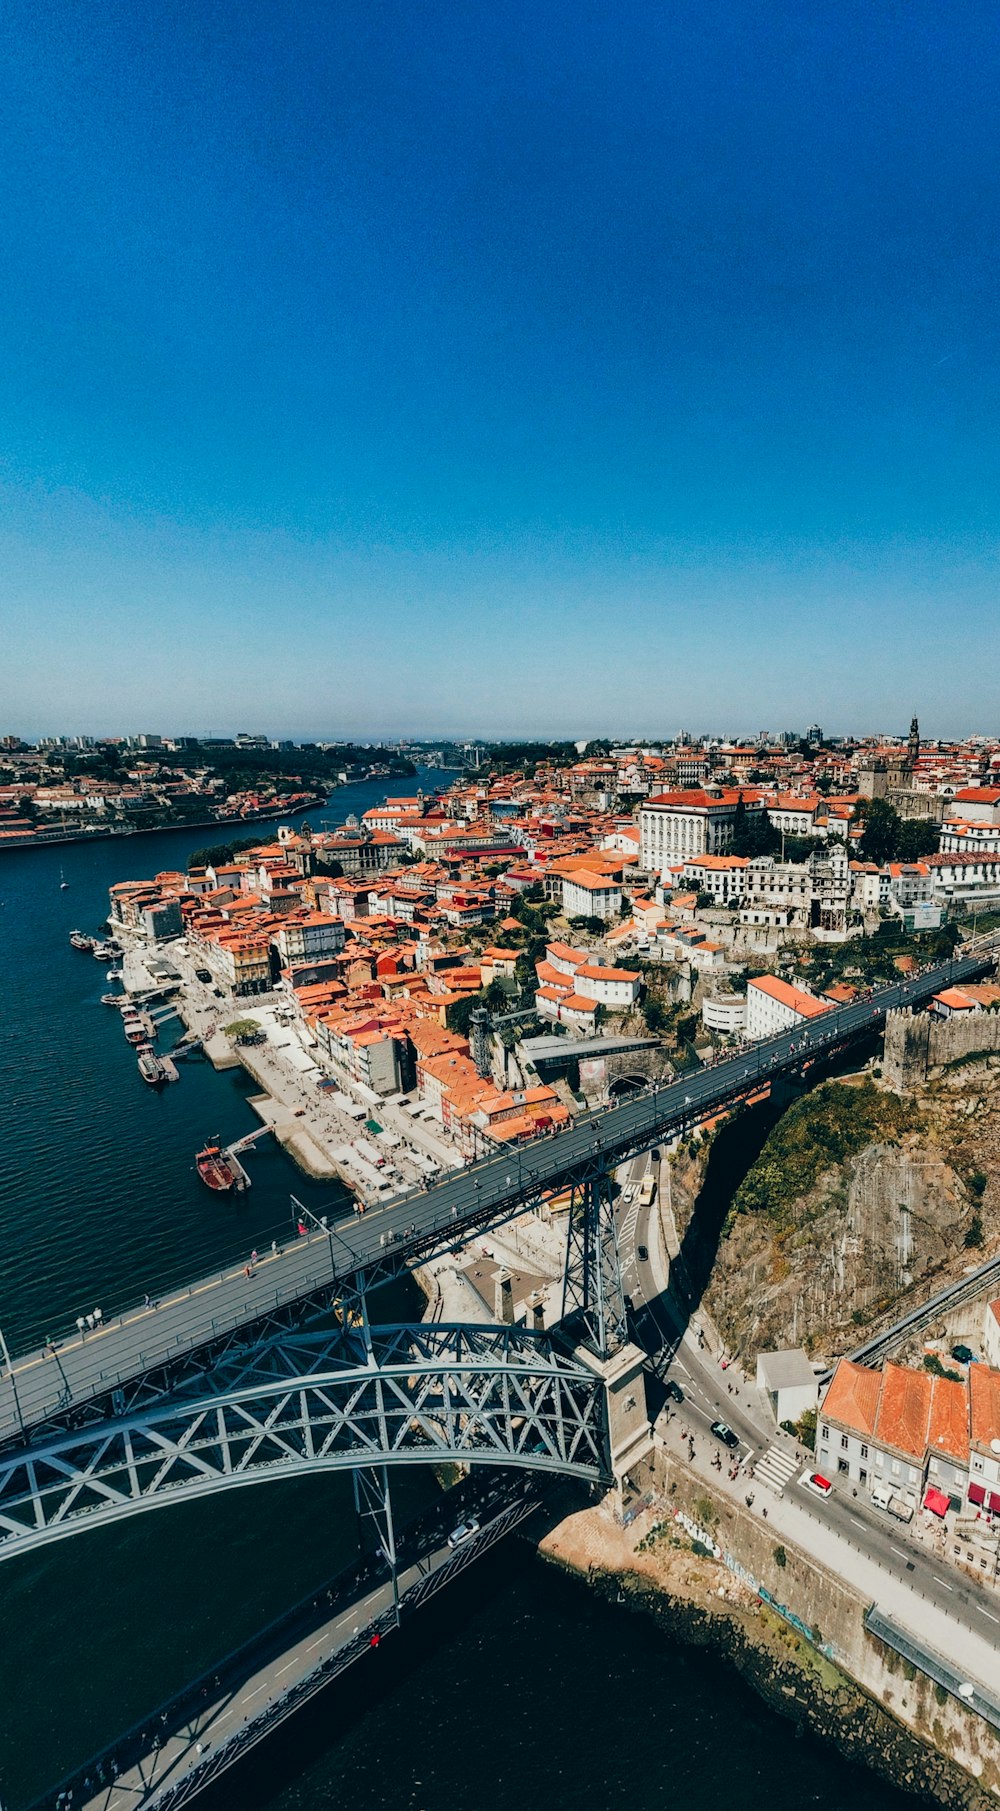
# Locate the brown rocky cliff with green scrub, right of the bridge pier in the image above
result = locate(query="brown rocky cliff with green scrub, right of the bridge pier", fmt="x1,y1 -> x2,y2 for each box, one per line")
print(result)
685,1059 -> 1000,1360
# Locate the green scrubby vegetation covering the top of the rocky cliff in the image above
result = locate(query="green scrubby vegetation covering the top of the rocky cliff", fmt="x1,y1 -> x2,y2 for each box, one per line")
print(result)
732,1079 -> 920,1226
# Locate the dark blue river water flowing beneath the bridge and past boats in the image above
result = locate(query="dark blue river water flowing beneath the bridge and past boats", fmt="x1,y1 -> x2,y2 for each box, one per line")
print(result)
0,771 -> 904,1811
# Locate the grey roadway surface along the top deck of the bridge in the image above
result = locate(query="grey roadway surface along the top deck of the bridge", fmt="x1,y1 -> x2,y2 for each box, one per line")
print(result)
0,940 -> 991,1442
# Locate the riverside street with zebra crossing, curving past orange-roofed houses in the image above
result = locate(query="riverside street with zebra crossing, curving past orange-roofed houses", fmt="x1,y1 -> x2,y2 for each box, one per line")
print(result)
621,1166 -> 1000,1684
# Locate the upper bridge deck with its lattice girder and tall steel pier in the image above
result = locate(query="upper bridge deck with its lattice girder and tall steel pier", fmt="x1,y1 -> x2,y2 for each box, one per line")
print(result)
0,938 -> 996,1499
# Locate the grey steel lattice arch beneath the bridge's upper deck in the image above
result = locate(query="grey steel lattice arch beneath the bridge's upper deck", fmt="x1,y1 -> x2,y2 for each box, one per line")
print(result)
0,1324 -> 609,1559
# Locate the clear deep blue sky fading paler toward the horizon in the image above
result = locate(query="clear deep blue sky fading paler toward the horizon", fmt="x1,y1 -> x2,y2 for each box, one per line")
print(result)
0,0 -> 1000,735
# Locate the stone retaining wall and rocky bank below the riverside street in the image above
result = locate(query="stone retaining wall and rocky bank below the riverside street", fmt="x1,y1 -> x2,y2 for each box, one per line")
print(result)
540,1454 -> 1000,1811
